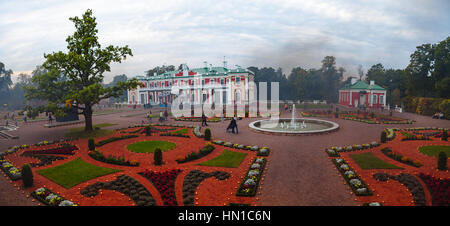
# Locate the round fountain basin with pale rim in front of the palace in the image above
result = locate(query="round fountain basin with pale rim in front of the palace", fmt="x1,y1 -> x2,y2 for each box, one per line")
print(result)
249,118 -> 339,135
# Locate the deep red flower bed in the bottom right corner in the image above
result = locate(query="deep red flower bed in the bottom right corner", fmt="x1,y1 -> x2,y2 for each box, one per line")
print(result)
418,173 -> 450,206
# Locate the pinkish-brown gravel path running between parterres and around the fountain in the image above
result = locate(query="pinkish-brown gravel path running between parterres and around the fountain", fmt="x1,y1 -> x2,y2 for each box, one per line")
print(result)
0,107 -> 450,206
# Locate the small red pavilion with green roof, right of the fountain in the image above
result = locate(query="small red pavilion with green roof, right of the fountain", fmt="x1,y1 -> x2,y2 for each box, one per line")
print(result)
339,78 -> 386,108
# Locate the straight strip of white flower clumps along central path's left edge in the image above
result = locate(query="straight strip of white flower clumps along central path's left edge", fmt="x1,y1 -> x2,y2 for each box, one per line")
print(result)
236,157 -> 267,196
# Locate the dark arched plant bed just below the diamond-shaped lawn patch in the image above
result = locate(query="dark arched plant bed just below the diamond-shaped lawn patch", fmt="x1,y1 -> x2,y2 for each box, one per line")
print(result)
80,174 -> 156,206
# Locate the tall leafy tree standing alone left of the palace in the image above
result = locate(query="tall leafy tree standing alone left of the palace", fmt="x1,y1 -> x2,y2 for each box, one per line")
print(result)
22,9 -> 139,131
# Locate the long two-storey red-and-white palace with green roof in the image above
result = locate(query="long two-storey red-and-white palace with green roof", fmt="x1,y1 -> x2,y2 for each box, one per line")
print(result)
128,61 -> 254,105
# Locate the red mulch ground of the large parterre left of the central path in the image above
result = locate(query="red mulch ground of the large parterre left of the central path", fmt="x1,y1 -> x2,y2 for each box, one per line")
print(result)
0,126 -> 268,206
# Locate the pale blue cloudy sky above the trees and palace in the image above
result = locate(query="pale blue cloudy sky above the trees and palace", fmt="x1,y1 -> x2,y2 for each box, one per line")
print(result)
0,0 -> 450,82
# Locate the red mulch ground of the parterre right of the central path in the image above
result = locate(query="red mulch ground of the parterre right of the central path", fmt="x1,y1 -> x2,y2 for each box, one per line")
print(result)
339,131 -> 450,206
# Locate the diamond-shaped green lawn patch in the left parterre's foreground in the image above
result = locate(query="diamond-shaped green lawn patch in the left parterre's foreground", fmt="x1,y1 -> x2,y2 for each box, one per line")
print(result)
37,158 -> 121,188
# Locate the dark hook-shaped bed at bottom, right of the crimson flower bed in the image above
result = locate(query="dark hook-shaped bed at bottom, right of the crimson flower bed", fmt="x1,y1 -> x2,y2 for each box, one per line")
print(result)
183,170 -> 230,206
